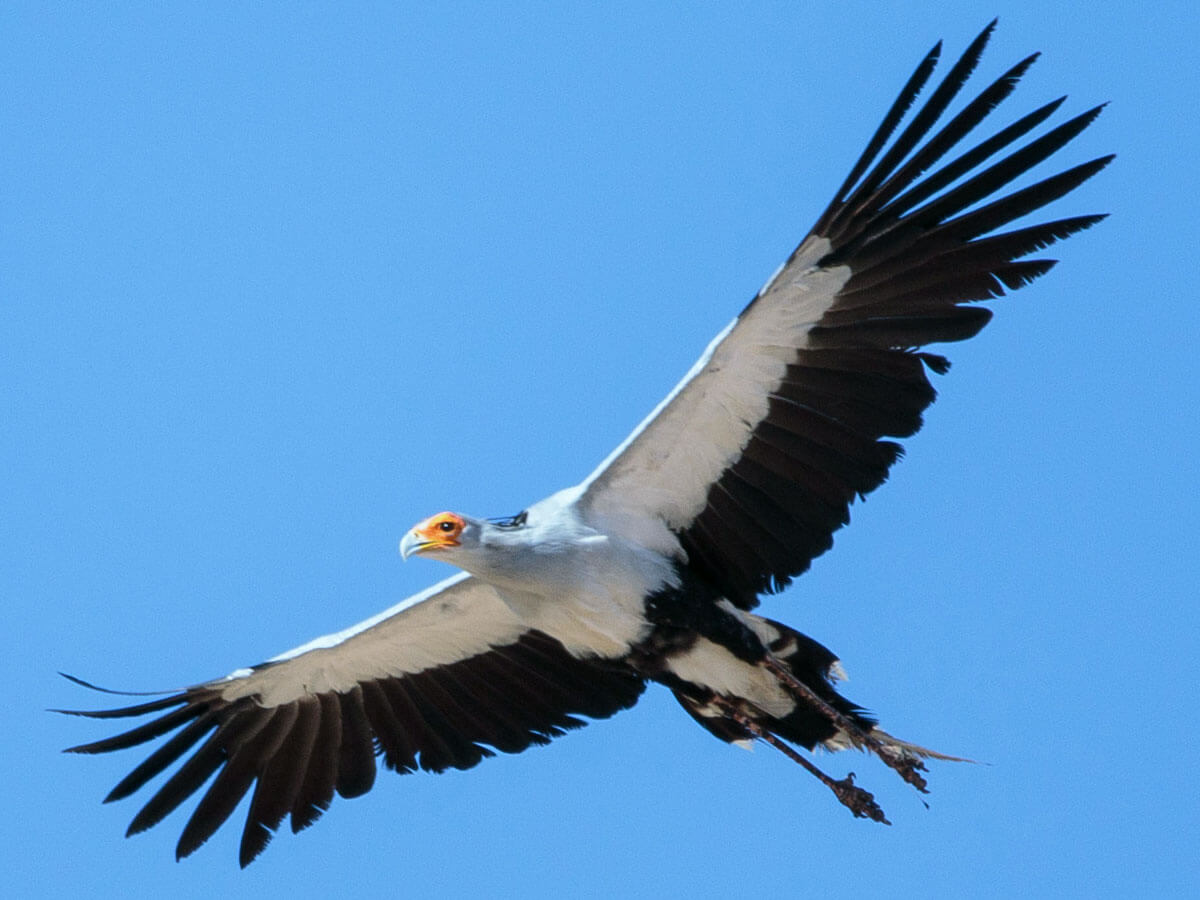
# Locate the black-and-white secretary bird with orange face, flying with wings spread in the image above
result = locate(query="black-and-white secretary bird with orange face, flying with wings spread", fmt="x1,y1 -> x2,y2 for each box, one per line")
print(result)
62,23 -> 1112,866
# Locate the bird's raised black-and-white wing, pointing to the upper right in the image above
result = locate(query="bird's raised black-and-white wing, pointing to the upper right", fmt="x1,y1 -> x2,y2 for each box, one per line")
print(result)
580,23 -> 1112,608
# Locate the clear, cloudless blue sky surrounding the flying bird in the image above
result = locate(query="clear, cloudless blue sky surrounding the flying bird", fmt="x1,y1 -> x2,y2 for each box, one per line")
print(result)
0,2 -> 1200,900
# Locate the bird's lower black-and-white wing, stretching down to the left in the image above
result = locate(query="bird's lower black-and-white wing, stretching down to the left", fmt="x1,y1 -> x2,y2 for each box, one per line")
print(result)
62,576 -> 643,866
